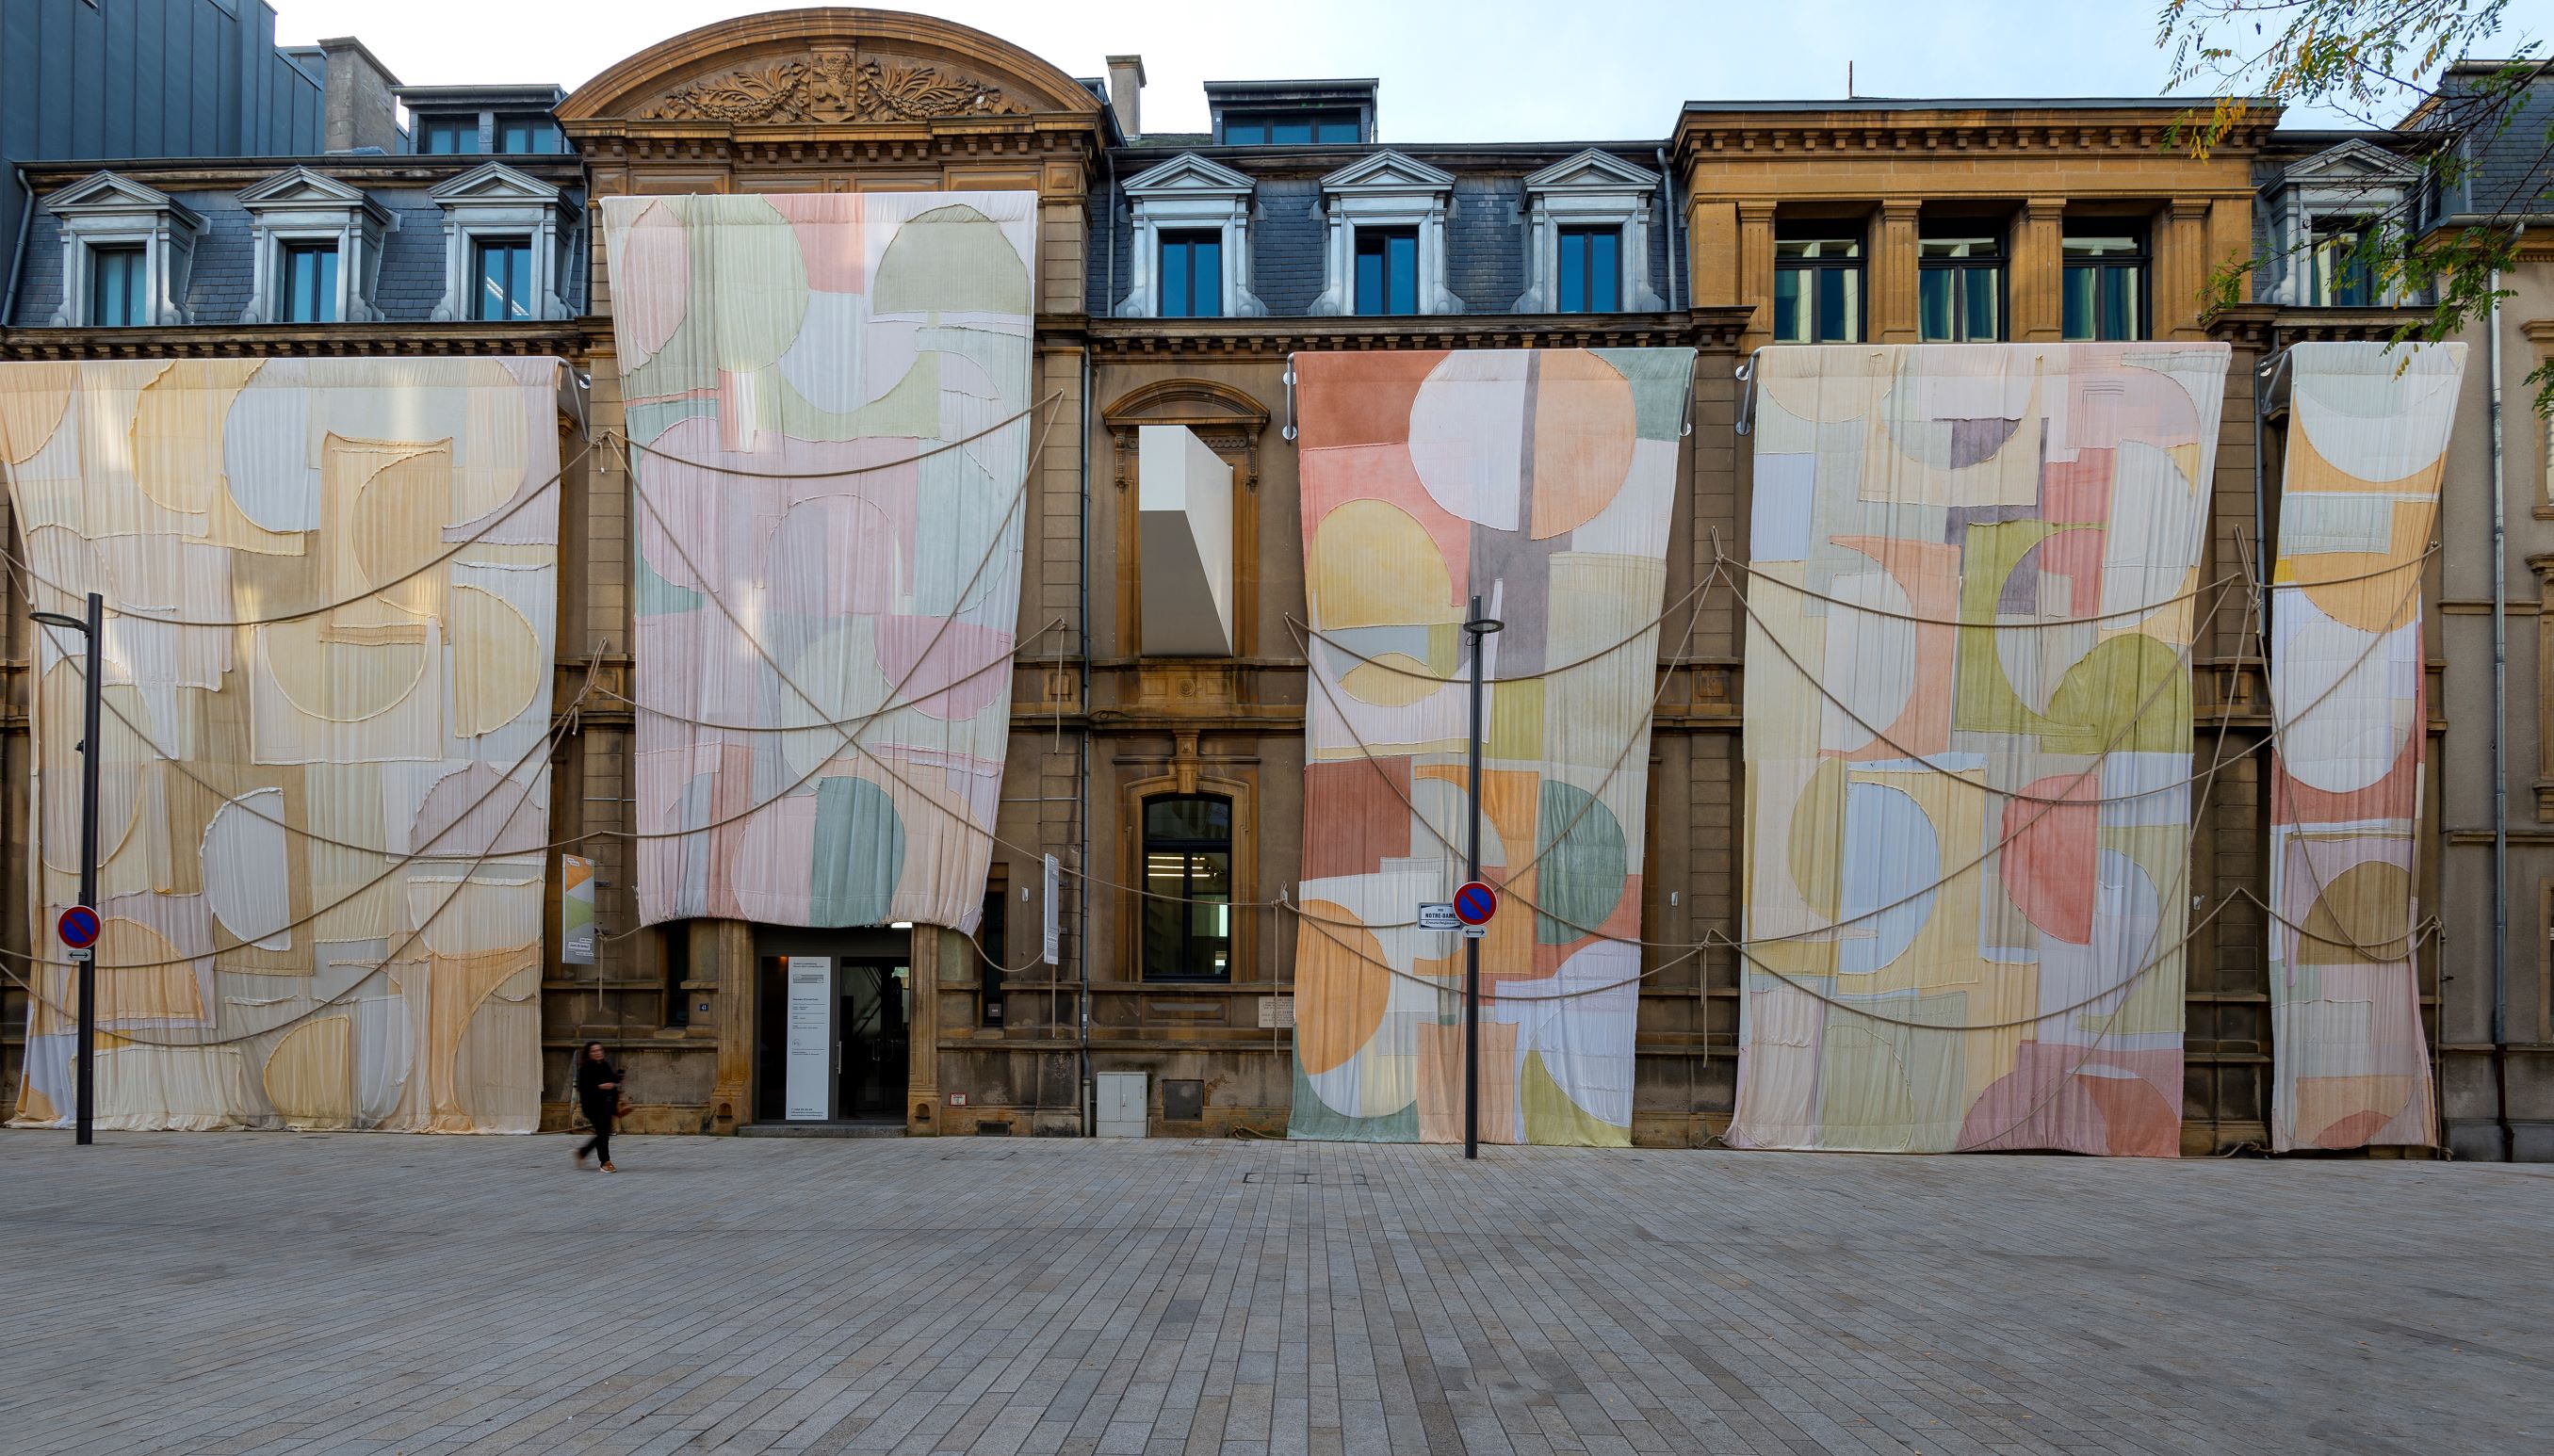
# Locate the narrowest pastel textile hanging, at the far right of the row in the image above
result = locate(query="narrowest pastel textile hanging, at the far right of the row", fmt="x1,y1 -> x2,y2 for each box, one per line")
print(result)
2270,342 -> 2465,1152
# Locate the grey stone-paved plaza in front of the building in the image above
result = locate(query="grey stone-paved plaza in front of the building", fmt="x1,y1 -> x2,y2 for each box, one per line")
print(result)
0,1132 -> 2554,1456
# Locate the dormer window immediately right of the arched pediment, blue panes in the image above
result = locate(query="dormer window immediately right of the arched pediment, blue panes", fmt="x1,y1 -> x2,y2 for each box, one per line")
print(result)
1116,154 -> 1267,319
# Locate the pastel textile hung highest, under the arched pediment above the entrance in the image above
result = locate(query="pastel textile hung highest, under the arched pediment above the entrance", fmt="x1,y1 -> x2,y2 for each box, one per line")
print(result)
603,191 -> 1037,930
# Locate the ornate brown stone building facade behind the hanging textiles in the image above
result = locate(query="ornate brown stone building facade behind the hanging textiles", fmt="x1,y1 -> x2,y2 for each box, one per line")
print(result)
0,10 -> 2554,1157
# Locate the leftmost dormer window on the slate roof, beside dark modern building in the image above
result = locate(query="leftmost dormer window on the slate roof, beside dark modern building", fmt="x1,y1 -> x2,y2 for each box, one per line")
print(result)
43,171 -> 204,330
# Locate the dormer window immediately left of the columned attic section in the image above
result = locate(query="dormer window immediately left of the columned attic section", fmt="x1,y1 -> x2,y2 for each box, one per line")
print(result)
1515,148 -> 1667,315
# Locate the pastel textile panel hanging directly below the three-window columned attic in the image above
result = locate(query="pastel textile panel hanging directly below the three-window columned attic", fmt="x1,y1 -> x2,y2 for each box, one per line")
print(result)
1729,342 -> 2227,1157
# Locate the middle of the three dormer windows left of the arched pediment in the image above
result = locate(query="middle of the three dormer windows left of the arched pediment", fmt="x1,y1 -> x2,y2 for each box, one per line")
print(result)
240,166 -> 391,324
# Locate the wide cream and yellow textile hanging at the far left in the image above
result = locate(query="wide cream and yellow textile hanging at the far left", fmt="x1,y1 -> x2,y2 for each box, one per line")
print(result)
0,358 -> 561,1132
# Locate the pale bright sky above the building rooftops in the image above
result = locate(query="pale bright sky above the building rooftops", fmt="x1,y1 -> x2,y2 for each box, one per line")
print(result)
268,0 -> 2554,143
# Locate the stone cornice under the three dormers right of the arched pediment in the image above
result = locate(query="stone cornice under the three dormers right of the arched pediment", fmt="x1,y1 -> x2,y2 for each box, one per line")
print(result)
1088,306 -> 1754,360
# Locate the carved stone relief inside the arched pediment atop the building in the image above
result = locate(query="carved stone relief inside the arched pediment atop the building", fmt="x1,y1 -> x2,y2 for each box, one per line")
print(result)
639,46 -> 1030,125
